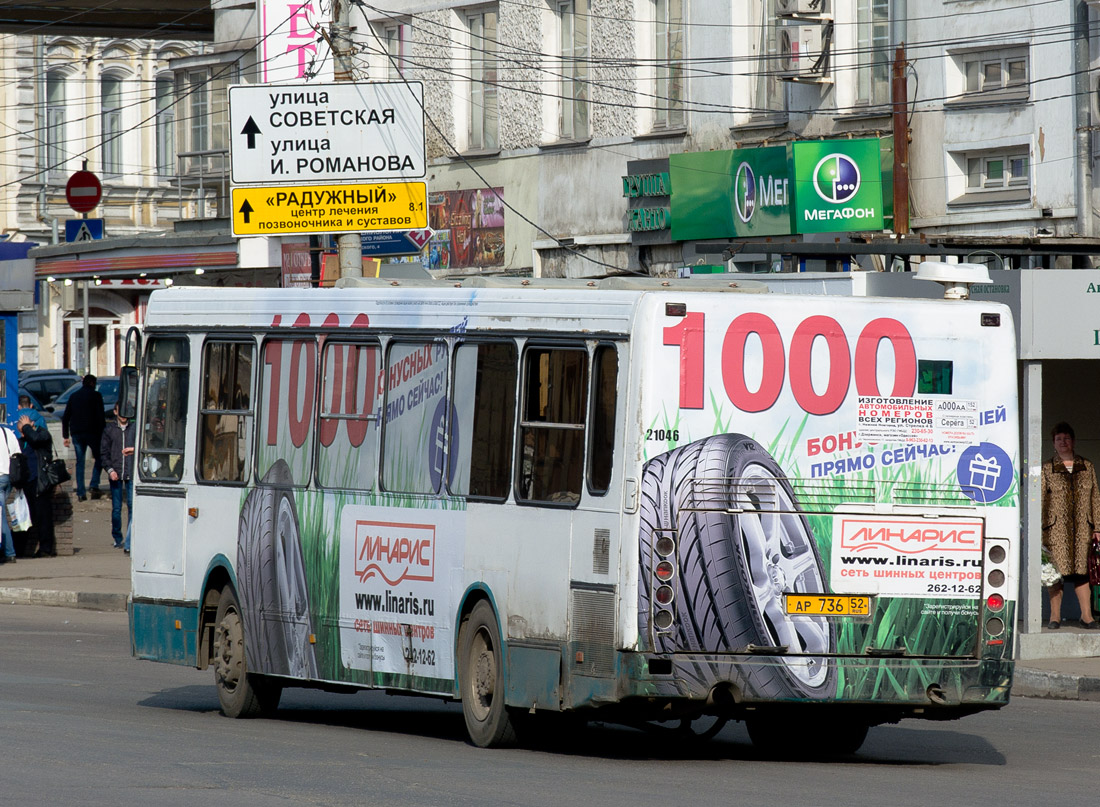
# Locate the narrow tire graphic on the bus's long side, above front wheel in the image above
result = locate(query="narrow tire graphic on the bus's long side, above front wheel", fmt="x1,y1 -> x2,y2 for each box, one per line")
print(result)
237,460 -> 317,678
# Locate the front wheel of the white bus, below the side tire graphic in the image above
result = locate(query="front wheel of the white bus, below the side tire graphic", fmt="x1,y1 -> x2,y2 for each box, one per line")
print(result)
213,586 -> 283,717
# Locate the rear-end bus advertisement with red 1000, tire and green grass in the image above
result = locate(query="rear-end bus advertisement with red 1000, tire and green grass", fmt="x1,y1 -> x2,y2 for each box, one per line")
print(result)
639,297 -> 1020,701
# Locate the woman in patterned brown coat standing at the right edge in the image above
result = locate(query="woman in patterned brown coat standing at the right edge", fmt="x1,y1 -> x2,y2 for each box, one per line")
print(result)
1043,422 -> 1100,630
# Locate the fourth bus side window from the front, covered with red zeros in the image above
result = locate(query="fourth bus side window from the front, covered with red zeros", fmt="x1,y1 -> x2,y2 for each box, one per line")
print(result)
317,339 -> 382,490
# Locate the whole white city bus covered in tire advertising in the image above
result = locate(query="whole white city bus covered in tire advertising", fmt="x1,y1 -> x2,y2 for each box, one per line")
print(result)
131,276 -> 1020,752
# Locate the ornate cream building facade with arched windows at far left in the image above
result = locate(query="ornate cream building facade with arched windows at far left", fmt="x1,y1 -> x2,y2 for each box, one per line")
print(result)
0,34 -> 205,375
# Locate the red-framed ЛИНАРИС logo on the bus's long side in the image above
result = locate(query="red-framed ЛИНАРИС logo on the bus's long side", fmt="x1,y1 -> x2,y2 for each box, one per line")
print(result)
355,520 -> 436,586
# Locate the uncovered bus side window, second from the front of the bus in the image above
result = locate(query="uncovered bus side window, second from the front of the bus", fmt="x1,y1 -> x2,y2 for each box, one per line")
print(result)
196,342 -> 255,482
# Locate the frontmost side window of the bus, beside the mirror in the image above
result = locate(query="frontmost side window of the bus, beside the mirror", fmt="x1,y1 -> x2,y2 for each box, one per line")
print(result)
138,336 -> 190,482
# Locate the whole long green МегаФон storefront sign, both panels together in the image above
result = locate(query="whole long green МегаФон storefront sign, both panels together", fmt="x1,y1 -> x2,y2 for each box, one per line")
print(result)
669,139 -> 889,241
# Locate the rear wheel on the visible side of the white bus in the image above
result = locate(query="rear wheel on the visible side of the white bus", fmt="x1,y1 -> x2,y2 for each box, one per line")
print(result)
459,600 -> 516,748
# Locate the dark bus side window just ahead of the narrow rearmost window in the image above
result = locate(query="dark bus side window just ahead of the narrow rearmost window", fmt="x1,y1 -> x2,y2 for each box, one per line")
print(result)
517,347 -> 589,505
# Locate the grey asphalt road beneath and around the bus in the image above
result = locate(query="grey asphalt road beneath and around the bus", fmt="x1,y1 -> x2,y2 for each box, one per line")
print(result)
0,605 -> 1100,807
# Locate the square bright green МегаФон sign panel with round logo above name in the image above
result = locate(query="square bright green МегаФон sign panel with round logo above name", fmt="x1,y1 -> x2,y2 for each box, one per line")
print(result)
791,139 -> 883,233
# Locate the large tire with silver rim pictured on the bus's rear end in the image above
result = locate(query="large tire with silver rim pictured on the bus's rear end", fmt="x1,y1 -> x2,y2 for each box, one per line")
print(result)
639,434 -> 837,698
